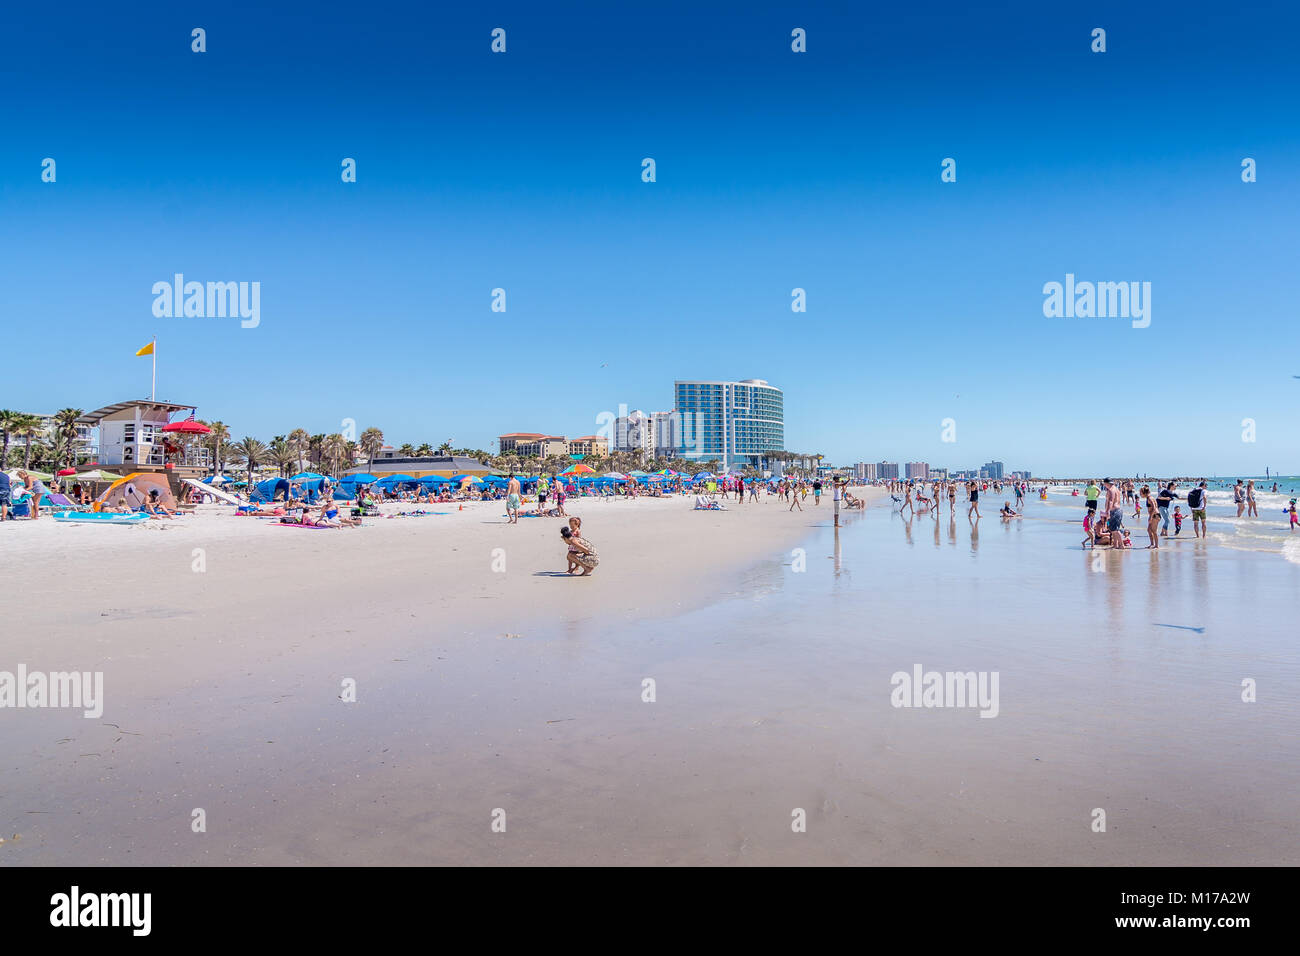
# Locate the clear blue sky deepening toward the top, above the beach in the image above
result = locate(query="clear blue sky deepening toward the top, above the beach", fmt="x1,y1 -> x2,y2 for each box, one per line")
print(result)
0,3 -> 1300,473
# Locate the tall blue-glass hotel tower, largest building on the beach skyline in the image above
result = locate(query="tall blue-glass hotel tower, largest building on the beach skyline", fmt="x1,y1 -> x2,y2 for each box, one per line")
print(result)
673,378 -> 785,468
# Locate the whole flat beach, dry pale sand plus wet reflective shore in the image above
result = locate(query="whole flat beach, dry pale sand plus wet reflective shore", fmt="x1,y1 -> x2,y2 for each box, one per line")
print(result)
0,493 -> 1300,865
